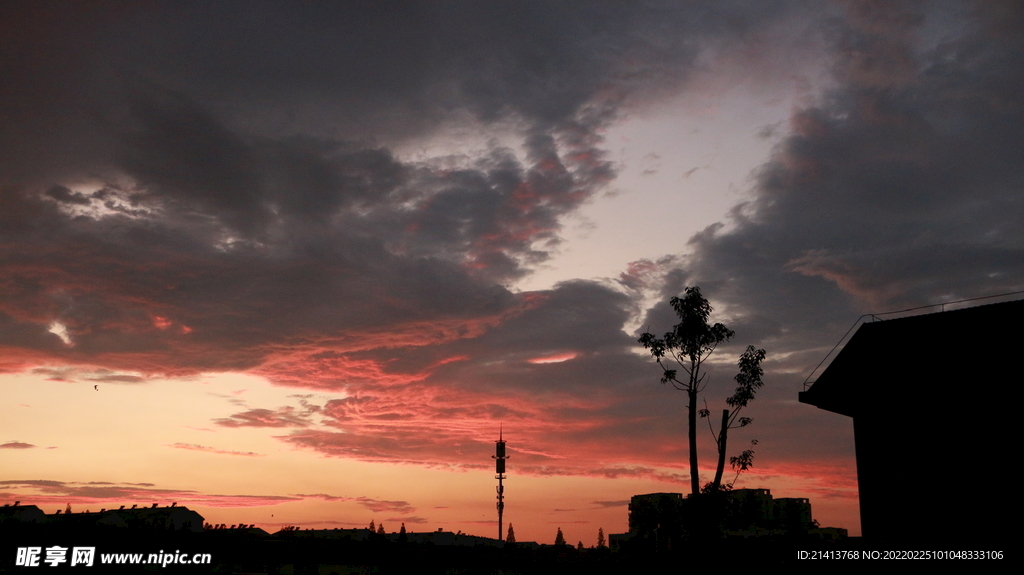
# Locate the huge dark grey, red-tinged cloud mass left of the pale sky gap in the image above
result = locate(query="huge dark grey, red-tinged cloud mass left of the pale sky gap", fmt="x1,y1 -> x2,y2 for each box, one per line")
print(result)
0,2 -> 811,374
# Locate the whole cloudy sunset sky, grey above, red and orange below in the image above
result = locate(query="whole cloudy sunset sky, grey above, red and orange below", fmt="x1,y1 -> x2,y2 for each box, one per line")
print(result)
0,0 -> 1024,545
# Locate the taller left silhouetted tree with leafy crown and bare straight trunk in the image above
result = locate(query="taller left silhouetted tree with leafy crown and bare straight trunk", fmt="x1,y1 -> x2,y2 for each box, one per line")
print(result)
639,285 -> 735,494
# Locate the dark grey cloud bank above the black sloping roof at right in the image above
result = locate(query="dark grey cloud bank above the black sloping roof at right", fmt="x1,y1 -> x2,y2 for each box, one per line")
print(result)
634,2 -> 1024,421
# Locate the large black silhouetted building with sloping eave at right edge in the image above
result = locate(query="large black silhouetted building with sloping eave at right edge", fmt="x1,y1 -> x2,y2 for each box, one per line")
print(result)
800,301 -> 1024,548
